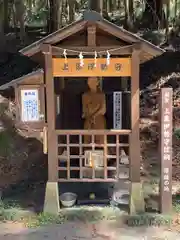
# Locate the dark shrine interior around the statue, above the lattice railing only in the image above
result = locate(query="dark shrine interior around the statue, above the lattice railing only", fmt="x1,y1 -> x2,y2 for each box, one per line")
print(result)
54,77 -> 130,130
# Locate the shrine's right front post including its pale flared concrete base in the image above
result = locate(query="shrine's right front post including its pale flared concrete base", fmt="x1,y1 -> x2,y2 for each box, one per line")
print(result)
130,45 -> 144,214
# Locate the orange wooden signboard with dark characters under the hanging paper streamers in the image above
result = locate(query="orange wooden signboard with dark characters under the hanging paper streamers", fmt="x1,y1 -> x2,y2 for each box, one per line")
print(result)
52,58 -> 131,77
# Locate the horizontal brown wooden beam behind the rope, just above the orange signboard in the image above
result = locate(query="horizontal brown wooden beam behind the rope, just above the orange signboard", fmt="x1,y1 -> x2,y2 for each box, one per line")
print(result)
52,45 -> 133,57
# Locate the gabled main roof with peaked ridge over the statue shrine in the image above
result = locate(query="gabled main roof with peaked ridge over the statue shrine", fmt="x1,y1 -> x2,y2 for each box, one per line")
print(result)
20,11 -> 165,61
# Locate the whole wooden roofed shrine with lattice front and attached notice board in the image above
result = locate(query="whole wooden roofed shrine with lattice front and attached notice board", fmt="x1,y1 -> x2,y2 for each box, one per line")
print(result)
1,11 -> 164,213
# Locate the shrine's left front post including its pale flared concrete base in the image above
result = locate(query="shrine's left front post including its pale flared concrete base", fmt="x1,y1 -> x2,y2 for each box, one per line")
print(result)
42,45 -> 59,214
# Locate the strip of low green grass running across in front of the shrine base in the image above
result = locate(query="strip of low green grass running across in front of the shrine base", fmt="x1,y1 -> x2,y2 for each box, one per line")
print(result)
0,201 -> 180,228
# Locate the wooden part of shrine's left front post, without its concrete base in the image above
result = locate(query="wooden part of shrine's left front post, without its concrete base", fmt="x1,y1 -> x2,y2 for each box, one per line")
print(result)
42,45 -> 58,182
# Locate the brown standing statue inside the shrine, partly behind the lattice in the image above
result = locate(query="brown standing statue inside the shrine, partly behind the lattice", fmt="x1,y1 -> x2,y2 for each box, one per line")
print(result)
82,77 -> 106,144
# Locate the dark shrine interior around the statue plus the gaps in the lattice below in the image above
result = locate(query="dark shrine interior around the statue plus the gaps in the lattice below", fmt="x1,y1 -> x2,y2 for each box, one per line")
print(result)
54,77 -> 130,182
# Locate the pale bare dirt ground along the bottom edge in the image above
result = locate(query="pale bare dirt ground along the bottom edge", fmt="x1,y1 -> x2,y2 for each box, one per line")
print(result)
0,221 -> 180,240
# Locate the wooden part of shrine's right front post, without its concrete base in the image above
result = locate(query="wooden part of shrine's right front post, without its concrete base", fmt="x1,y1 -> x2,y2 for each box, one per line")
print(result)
130,46 -> 141,183
